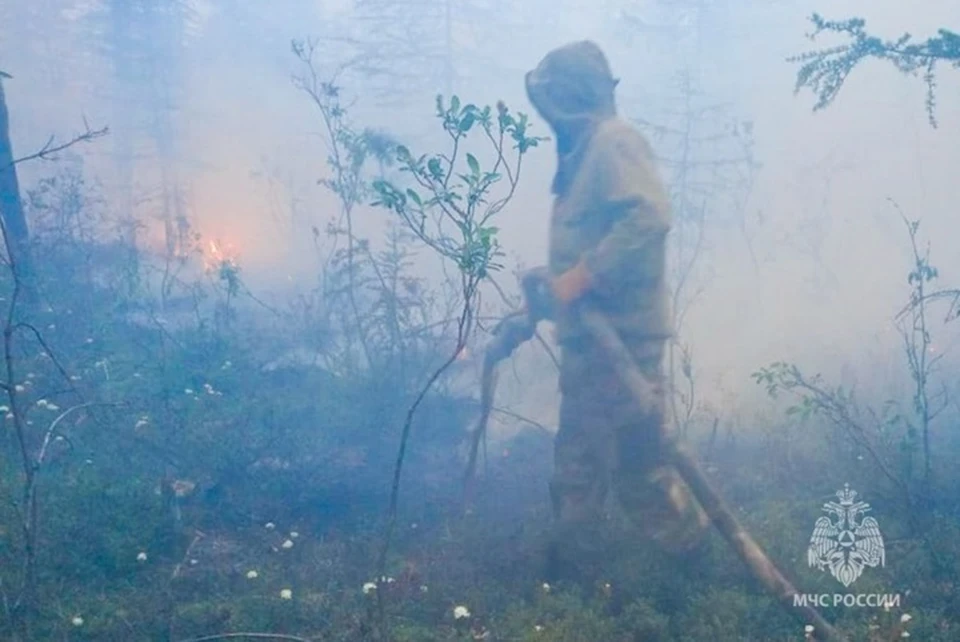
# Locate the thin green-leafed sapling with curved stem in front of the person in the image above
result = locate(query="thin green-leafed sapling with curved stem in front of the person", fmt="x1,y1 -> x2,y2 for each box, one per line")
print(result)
373,96 -> 545,627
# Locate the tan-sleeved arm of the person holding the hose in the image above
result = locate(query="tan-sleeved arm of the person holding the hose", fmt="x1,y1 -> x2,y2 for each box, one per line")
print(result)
551,131 -> 670,304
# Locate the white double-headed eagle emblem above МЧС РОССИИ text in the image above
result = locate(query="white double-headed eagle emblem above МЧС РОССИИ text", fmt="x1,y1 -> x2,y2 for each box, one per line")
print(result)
807,484 -> 886,586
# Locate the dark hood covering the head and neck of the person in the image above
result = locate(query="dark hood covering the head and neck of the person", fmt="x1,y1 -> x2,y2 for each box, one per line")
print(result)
526,40 -> 618,196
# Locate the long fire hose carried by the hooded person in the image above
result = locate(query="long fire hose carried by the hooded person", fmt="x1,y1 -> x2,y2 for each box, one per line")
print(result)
464,268 -> 847,642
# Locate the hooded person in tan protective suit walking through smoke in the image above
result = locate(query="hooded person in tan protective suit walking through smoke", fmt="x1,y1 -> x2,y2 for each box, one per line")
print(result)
526,41 -> 708,579
